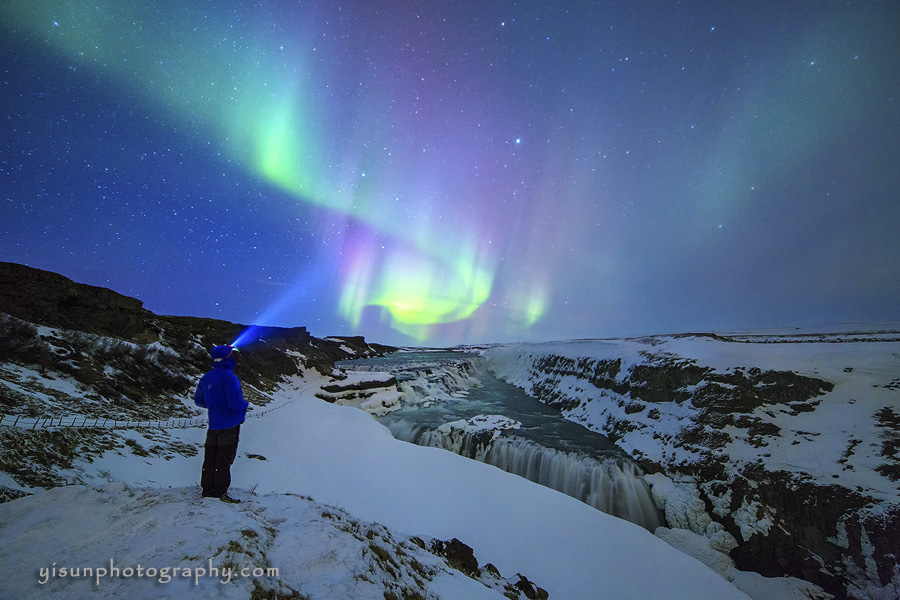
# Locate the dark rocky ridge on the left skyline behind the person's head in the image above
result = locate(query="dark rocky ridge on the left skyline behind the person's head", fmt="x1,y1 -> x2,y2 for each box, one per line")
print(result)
0,262 -> 394,388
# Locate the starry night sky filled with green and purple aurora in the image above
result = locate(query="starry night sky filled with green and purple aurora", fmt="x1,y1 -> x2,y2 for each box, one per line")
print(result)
0,0 -> 900,346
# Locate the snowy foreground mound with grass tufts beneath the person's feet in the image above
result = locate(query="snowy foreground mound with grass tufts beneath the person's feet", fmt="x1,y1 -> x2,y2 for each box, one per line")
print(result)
0,484 -> 520,600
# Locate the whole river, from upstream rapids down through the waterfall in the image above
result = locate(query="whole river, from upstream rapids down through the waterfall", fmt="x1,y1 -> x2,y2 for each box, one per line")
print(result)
340,353 -> 664,531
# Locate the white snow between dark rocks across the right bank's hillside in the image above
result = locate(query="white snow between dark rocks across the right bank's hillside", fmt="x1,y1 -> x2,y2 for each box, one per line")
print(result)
484,325 -> 900,599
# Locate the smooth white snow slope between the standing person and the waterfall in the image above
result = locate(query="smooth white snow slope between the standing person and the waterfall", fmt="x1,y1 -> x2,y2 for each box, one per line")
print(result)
233,384 -> 743,600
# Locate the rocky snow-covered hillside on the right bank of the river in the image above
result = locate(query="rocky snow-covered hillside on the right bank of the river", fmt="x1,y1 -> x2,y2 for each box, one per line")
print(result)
485,328 -> 900,600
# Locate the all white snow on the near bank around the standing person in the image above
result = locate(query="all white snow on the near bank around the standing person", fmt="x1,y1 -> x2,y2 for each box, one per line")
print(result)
0,374 -> 746,600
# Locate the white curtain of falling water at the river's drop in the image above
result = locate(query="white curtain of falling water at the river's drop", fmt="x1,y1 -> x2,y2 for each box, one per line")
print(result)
386,420 -> 663,532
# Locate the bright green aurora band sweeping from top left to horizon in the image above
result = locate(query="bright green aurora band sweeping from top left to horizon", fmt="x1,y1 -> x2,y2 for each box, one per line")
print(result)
0,0 -> 512,340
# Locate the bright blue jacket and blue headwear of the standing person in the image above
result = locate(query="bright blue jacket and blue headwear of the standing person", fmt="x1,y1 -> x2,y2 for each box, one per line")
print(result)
194,346 -> 249,430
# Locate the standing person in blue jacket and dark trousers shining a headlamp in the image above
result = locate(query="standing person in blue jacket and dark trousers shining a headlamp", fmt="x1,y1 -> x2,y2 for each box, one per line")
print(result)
194,346 -> 249,504
